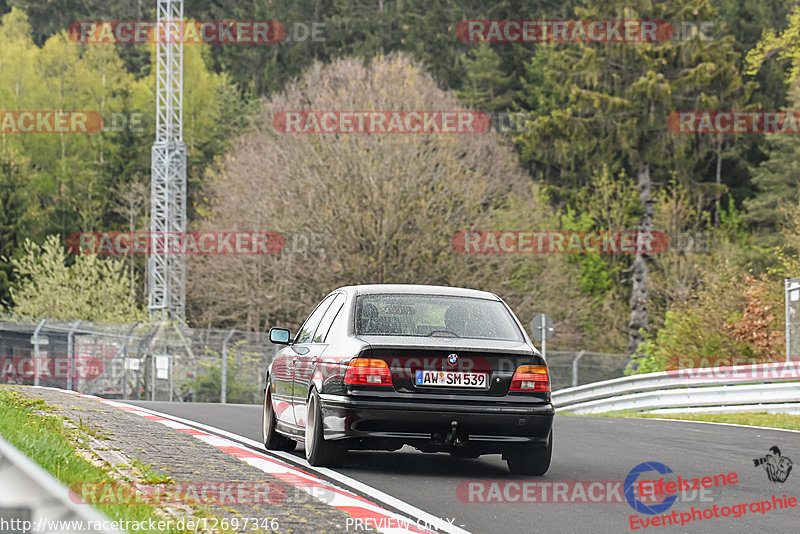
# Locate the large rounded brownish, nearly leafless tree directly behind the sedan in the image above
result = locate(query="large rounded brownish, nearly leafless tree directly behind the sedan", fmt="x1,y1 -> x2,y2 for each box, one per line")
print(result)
187,56 -> 547,329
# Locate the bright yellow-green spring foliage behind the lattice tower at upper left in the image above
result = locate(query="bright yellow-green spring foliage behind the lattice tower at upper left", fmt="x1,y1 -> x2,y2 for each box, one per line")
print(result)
0,7 -> 247,272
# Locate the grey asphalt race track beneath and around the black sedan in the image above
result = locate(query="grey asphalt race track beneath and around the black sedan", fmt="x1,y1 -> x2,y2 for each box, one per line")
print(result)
129,401 -> 800,534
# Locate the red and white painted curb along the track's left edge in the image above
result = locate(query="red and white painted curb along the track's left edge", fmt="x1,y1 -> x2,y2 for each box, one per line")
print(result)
37,386 -> 468,534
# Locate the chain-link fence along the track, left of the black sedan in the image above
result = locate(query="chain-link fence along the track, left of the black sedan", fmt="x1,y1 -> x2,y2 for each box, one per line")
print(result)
0,315 -> 275,403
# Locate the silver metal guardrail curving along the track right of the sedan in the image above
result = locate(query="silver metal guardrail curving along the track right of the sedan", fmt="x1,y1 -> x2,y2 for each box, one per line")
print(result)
553,362 -> 800,414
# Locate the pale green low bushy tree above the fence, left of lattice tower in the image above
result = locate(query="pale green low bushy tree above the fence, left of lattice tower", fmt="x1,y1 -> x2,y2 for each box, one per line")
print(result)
10,236 -> 144,322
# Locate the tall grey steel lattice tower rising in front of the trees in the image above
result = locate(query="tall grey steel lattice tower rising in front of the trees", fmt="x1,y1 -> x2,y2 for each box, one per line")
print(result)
147,0 -> 186,322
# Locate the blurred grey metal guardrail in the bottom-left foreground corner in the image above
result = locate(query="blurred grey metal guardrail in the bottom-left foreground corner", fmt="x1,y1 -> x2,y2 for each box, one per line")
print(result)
0,437 -> 125,534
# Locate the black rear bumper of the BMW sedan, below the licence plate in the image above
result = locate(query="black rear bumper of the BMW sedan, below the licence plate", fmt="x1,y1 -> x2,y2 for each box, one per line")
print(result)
320,394 -> 554,452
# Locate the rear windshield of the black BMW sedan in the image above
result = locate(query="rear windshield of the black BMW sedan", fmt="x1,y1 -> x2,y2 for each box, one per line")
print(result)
356,294 -> 523,341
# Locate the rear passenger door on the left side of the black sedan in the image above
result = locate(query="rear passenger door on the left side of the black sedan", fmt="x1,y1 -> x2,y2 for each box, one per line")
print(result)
288,293 -> 337,426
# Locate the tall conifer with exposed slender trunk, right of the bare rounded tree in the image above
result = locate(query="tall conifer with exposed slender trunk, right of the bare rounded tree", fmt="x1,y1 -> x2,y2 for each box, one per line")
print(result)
518,0 -> 752,354
